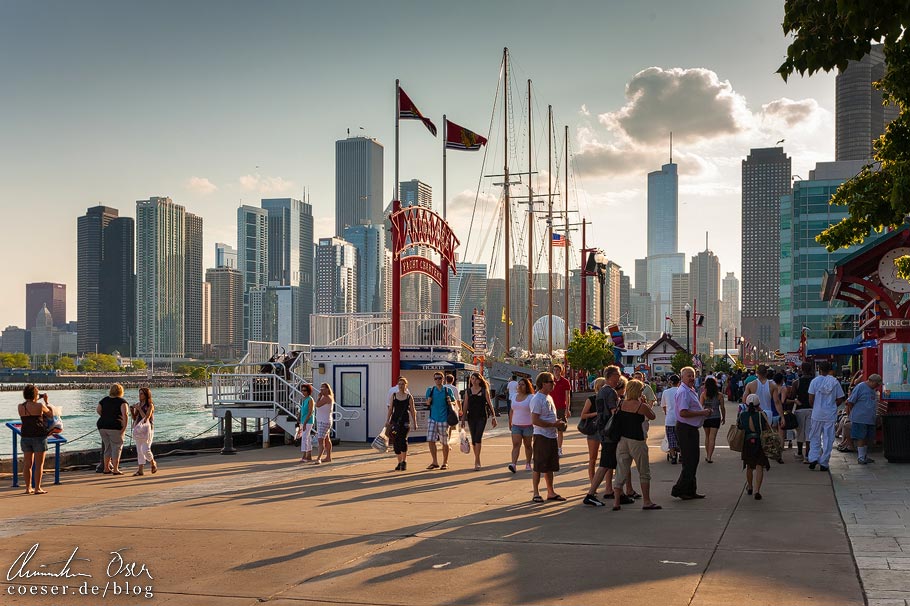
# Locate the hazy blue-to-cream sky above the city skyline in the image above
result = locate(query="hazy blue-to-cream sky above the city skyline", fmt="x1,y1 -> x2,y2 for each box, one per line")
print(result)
0,0 -> 834,327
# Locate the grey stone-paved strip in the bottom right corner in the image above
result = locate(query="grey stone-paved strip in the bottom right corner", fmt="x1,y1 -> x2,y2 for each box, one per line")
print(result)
831,444 -> 910,606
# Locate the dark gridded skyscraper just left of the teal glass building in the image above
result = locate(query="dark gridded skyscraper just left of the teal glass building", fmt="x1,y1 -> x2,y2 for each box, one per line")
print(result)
742,147 -> 793,351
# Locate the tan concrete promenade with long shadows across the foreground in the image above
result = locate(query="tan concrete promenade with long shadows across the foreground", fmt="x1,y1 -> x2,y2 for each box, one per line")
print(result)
0,406 -> 884,606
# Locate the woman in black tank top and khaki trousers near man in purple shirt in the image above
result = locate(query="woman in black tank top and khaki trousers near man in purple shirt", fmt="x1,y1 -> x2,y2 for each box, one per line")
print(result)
611,379 -> 661,511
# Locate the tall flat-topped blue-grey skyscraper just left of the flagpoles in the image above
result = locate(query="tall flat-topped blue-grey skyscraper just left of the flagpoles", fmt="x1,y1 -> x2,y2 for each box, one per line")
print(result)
335,137 -> 385,236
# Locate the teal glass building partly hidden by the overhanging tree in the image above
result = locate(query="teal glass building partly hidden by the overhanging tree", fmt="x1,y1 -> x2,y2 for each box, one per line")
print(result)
779,160 -> 864,352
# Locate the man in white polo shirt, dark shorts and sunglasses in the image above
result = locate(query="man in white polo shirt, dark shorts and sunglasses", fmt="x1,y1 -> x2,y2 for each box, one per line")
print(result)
530,372 -> 566,503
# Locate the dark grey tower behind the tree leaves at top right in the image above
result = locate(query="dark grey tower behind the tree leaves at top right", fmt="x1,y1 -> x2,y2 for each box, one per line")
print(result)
834,44 -> 900,162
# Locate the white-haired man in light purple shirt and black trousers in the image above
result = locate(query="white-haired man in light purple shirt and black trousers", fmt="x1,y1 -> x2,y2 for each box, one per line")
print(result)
670,366 -> 711,501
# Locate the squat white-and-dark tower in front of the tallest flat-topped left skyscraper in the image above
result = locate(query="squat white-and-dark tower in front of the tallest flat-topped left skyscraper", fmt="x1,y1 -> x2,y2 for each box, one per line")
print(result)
315,238 -> 358,314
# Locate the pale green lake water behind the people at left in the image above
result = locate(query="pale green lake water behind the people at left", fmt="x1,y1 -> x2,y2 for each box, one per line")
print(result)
0,387 -> 218,458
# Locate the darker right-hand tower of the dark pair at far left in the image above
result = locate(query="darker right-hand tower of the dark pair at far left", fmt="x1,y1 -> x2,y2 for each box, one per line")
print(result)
98,217 -> 136,356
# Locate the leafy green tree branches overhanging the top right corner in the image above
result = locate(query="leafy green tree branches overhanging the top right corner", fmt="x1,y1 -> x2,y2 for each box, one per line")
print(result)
777,0 -> 910,278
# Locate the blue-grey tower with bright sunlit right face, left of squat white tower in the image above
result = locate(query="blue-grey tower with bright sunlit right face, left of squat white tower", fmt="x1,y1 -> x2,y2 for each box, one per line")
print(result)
262,198 -> 314,343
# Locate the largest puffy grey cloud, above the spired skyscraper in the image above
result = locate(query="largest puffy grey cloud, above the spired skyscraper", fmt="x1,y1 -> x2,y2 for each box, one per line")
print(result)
598,67 -> 750,144
